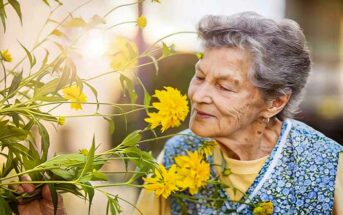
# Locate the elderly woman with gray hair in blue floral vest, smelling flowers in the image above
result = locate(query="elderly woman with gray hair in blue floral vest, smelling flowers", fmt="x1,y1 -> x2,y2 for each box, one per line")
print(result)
137,12 -> 343,215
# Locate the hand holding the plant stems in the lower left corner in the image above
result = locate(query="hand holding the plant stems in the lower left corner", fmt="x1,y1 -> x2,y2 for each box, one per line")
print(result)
16,176 -> 67,215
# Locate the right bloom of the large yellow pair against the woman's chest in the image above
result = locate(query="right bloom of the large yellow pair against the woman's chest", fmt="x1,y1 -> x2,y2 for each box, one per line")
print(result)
175,152 -> 210,195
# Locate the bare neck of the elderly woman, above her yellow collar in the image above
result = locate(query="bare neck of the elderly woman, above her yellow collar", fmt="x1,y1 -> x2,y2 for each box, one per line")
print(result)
215,119 -> 282,160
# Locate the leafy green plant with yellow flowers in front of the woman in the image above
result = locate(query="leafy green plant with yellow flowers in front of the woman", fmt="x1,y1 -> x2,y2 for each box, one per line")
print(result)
0,0 -> 273,215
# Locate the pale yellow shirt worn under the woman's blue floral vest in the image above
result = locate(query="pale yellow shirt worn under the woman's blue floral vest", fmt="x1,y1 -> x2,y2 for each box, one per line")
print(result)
136,148 -> 343,215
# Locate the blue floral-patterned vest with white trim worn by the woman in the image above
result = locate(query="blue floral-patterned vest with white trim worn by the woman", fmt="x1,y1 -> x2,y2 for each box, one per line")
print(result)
163,119 -> 343,214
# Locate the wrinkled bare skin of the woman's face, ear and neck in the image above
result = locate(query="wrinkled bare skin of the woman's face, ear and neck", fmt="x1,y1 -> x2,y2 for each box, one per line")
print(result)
188,48 -> 289,160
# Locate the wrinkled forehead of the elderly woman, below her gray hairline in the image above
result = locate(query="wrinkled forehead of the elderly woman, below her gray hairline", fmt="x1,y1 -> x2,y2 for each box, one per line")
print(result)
196,47 -> 251,81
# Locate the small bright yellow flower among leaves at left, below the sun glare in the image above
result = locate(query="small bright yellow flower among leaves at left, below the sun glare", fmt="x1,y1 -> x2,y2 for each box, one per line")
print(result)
63,85 -> 87,110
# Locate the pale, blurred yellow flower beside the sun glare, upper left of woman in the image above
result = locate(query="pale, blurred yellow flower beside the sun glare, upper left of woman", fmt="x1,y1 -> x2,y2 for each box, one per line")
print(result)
109,37 -> 138,71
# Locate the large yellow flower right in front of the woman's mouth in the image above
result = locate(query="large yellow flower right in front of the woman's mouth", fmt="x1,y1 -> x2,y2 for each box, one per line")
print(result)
145,87 -> 189,132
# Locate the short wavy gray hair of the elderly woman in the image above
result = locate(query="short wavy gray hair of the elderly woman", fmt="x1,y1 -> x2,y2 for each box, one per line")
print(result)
198,12 -> 311,119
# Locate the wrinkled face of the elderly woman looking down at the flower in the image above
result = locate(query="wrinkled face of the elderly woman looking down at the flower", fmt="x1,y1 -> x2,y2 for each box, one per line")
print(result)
188,48 -> 266,138
